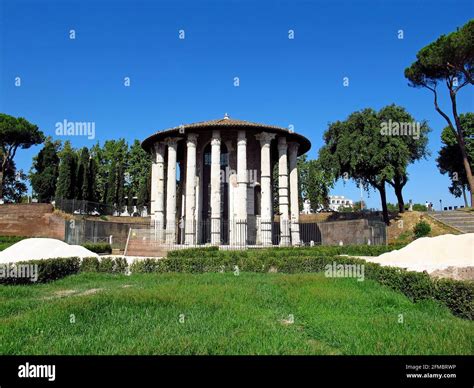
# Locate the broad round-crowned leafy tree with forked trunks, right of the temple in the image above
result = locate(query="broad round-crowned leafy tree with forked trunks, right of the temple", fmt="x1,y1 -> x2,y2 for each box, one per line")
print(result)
319,105 -> 428,225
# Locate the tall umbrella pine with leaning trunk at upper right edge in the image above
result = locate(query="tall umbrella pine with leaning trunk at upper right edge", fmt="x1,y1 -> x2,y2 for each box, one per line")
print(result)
405,20 -> 474,206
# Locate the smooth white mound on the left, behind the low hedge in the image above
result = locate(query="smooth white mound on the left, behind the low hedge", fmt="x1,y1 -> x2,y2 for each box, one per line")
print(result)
0,238 -> 99,263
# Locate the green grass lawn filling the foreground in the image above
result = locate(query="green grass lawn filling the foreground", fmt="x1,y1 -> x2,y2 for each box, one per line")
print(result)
0,273 -> 474,355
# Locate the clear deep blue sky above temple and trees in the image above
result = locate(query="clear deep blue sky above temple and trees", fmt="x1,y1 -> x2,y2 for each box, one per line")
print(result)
0,0 -> 474,208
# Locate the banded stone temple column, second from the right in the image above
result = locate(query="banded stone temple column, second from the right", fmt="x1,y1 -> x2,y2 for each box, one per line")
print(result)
278,137 -> 291,246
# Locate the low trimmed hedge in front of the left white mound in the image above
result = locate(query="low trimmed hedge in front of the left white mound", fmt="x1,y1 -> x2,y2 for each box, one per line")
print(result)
0,257 -> 80,284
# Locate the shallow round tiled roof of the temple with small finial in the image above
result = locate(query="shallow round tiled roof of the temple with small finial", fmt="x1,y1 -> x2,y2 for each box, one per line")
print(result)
142,114 -> 311,155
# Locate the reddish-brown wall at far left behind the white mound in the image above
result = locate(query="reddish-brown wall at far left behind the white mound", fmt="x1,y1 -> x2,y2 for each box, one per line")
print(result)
0,203 -> 65,240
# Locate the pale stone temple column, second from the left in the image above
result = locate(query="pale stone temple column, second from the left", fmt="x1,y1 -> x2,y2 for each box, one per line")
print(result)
165,137 -> 180,244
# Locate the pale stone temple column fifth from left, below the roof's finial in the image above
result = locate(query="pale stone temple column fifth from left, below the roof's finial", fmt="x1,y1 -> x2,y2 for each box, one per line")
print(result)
234,130 -> 248,245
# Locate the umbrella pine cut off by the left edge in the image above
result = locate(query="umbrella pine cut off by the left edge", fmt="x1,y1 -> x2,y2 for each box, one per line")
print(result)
0,113 -> 44,199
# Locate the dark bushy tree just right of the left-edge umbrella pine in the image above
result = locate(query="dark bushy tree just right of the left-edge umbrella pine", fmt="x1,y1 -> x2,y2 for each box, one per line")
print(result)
29,137 -> 61,202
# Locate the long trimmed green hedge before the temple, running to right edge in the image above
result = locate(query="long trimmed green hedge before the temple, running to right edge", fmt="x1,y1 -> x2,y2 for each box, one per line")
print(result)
130,251 -> 474,320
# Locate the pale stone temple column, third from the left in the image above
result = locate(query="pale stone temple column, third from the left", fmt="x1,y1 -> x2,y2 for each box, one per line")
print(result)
184,133 -> 198,245
